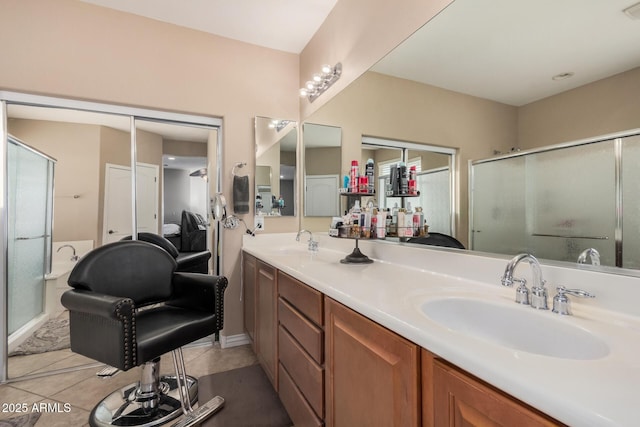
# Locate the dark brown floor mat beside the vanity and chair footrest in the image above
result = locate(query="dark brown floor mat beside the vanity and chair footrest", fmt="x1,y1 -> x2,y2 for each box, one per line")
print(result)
198,365 -> 293,427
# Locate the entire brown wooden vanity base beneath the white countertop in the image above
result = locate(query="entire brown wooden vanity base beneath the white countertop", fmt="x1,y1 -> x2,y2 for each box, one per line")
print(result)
242,253 -> 562,427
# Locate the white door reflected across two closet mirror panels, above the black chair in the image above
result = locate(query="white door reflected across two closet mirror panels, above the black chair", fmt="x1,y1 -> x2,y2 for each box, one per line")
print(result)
102,163 -> 158,244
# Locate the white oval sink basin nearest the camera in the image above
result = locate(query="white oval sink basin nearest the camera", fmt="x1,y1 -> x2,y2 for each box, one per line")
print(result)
420,297 -> 609,360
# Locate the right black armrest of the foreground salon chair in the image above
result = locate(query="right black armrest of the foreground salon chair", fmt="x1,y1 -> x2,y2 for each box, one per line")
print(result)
166,272 -> 228,330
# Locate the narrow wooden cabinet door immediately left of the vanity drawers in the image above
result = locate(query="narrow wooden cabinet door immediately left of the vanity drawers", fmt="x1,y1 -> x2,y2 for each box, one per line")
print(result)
256,261 -> 278,389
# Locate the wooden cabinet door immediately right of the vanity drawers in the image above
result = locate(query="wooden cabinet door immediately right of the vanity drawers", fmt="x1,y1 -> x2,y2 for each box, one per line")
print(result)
325,297 -> 420,427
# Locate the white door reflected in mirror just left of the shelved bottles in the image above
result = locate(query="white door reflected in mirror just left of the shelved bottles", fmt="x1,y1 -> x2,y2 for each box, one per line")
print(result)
304,175 -> 340,216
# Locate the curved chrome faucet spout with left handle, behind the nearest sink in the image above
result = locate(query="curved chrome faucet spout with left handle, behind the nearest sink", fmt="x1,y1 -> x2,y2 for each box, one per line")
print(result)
501,254 -> 549,310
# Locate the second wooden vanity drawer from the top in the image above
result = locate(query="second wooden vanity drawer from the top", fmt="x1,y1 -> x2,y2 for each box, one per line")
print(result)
278,298 -> 323,365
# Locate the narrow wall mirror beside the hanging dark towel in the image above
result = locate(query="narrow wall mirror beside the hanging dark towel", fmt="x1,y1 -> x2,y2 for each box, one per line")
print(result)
254,117 -> 298,217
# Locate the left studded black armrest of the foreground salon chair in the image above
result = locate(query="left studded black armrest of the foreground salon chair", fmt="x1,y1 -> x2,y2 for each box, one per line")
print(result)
61,289 -> 138,371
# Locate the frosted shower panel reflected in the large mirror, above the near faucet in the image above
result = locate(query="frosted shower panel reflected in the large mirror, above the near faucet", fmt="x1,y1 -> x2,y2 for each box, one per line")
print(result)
526,140 -> 616,266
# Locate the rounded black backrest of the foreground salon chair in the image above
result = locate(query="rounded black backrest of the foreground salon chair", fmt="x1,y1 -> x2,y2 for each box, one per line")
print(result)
68,240 -> 177,307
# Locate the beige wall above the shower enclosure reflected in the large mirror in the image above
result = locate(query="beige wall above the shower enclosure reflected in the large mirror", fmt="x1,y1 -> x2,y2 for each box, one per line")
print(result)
518,67 -> 640,149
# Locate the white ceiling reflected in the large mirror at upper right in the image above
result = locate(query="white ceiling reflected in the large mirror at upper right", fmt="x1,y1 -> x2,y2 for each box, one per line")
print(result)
373,0 -> 640,106
